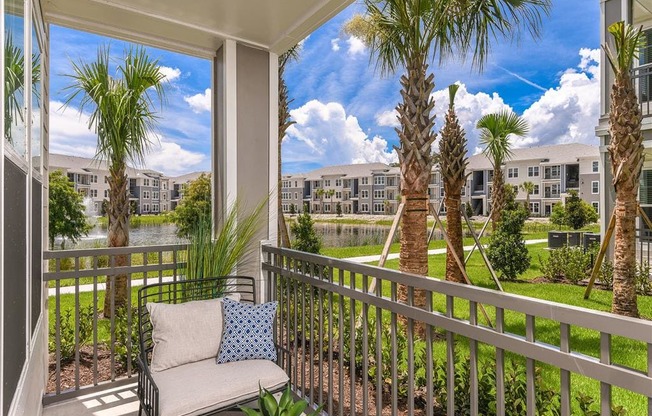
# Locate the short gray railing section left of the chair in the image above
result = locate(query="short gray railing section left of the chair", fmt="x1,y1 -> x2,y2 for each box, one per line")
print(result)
43,245 -> 186,404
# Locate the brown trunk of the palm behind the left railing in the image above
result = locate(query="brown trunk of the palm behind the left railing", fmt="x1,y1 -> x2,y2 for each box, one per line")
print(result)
104,163 -> 129,317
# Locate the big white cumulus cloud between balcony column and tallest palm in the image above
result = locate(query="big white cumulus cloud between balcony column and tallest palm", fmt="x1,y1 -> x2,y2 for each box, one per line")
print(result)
283,100 -> 397,166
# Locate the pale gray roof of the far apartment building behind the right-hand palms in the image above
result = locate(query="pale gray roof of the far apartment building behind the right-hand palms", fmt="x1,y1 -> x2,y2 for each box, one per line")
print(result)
468,143 -> 600,170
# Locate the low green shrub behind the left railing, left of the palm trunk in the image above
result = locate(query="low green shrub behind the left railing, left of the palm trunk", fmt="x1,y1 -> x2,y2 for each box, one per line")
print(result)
48,305 -> 94,361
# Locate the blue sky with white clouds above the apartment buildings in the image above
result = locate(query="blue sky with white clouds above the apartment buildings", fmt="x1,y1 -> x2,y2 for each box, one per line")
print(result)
51,0 -> 600,175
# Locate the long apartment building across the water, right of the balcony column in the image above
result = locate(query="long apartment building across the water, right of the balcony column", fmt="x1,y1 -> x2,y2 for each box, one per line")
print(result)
281,143 -> 600,216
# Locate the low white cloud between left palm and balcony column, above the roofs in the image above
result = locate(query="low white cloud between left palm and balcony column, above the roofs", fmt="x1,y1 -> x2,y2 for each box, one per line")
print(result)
146,137 -> 207,176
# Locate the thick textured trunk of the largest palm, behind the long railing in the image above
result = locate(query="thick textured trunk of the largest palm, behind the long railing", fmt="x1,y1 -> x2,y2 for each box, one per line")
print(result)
396,56 -> 436,337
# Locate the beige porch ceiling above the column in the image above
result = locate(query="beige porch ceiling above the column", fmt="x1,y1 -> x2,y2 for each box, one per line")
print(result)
42,0 -> 352,57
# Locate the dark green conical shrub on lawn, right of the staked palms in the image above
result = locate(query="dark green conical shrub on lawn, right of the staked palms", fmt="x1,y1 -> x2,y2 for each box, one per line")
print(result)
487,207 -> 530,280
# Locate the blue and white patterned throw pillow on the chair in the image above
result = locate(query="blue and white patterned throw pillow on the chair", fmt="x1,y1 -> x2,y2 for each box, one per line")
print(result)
217,298 -> 278,364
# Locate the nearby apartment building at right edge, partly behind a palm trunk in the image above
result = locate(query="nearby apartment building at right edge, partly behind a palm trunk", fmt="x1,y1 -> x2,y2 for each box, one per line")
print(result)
596,0 -> 652,238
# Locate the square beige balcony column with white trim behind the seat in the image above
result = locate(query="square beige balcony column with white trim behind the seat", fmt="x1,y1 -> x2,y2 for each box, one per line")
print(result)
212,40 -> 278,299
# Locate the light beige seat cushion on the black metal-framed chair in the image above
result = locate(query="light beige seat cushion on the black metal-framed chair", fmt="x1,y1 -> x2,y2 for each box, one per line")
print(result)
152,358 -> 288,416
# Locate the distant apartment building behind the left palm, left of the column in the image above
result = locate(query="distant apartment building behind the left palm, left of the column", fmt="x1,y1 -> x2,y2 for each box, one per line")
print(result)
50,154 -> 172,215
